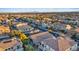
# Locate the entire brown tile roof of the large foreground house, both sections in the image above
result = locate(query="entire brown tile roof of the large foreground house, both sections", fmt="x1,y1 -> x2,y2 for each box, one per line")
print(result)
30,32 -> 76,51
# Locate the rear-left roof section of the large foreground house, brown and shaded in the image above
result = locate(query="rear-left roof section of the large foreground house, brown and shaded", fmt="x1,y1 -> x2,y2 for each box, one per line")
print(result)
30,32 -> 56,42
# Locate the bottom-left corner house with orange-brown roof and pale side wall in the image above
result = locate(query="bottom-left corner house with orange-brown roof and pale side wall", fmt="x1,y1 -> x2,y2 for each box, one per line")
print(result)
0,38 -> 23,51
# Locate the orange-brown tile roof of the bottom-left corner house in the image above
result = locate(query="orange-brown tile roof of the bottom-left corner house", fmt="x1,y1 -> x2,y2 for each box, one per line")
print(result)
0,38 -> 19,50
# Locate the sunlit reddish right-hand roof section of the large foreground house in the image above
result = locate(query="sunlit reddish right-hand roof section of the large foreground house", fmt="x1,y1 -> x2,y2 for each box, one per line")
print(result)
58,37 -> 76,51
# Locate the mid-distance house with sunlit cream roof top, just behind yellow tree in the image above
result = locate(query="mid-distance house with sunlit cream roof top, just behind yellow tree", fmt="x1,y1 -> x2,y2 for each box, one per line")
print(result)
16,23 -> 40,34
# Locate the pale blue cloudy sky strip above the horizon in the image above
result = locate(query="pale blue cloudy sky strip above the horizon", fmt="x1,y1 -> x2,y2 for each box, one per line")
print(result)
0,8 -> 79,12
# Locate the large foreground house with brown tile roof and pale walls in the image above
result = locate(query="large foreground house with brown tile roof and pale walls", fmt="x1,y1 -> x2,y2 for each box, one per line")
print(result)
30,32 -> 77,51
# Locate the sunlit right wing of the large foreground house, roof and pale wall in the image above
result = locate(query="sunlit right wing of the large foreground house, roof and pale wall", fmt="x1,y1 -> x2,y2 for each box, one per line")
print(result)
57,36 -> 77,51
